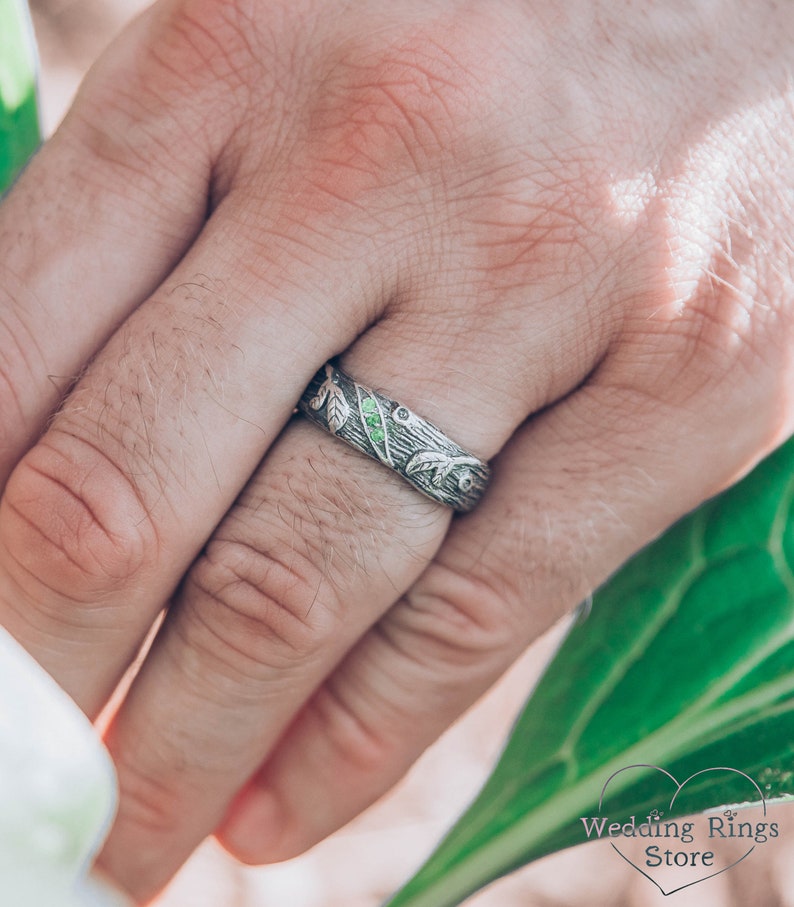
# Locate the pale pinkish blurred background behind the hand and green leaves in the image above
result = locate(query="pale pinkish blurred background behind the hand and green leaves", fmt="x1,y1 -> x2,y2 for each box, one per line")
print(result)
23,0 -> 794,907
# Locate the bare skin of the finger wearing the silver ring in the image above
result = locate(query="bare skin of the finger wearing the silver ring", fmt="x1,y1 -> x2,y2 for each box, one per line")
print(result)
93,247 -> 620,899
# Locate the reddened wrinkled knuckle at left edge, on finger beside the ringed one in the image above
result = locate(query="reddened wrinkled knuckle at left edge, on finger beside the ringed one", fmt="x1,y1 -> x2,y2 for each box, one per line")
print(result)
2,432 -> 157,605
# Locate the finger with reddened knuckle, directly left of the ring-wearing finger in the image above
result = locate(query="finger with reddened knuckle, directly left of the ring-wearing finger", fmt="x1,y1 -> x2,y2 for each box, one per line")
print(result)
0,172 -> 390,714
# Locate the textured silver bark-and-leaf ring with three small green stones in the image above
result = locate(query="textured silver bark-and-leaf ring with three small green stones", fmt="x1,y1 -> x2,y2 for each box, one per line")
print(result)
298,362 -> 490,513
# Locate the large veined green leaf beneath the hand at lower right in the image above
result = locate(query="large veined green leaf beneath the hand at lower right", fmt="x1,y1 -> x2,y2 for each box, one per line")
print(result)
388,440 -> 794,907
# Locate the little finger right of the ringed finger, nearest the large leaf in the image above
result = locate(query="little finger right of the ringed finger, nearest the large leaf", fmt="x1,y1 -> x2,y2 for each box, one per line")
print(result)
213,314 -> 785,863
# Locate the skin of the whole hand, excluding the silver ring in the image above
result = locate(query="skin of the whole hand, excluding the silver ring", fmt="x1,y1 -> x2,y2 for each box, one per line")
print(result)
0,0 -> 794,903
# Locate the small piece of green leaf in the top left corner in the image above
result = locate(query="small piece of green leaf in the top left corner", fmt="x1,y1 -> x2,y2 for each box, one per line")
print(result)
0,0 -> 40,193
